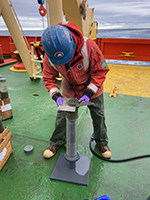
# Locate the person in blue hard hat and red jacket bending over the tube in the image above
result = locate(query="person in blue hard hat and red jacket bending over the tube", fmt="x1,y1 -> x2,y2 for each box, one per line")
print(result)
42,22 -> 111,158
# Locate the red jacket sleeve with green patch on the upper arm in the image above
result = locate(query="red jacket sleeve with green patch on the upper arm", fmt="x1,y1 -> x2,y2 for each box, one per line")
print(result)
85,39 -> 109,98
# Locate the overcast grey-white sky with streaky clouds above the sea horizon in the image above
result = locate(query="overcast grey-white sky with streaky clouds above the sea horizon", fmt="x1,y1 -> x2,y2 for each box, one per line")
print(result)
0,0 -> 150,29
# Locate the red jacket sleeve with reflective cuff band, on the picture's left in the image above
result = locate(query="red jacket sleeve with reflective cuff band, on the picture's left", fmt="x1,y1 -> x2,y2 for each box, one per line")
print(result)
43,54 -> 61,100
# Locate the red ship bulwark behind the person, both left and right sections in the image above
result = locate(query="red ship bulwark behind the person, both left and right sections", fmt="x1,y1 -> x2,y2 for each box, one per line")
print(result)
0,36 -> 150,62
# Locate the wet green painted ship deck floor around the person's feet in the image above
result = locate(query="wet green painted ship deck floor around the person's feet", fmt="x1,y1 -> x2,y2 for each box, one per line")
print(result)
0,65 -> 150,200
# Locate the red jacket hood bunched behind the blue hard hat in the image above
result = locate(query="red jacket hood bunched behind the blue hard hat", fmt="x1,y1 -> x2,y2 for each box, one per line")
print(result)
59,22 -> 84,52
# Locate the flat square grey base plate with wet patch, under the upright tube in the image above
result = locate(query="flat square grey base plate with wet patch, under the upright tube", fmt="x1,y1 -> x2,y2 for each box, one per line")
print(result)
50,153 -> 91,186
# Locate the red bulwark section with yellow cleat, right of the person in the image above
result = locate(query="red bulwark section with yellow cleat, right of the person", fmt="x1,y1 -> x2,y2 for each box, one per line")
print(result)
96,38 -> 150,62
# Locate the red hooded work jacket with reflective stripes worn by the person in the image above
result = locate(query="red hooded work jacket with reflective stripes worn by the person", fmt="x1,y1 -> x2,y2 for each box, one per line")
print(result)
43,22 -> 109,99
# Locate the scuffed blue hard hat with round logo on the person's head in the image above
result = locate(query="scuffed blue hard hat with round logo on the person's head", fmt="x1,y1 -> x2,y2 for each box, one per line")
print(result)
42,25 -> 73,65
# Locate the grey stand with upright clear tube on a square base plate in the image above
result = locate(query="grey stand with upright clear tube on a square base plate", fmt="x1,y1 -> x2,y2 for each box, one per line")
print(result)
50,105 -> 91,186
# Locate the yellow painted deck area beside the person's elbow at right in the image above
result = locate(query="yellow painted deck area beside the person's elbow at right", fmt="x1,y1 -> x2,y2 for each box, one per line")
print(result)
104,64 -> 150,98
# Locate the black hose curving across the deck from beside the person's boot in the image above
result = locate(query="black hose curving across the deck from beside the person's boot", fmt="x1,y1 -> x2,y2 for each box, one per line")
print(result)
89,135 -> 150,162
